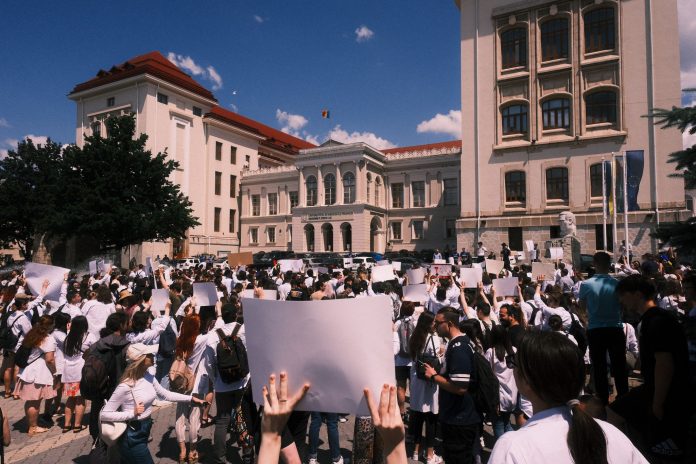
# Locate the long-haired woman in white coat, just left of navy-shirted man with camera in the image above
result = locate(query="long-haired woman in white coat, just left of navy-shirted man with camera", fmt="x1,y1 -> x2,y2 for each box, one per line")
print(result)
408,312 -> 444,464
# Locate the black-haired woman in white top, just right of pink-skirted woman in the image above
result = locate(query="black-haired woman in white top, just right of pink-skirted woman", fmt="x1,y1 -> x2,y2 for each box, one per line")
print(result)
62,316 -> 98,433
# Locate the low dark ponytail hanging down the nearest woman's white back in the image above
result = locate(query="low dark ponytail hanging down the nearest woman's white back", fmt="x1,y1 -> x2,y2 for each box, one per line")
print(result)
568,400 -> 609,464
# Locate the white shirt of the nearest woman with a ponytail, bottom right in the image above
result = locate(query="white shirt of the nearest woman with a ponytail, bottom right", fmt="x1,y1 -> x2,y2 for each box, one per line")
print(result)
488,406 -> 648,464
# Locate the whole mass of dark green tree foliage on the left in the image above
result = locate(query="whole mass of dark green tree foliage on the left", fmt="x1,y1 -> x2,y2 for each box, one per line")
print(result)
0,116 -> 199,257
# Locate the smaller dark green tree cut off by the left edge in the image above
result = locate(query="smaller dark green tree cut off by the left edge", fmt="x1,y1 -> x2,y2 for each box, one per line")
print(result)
0,139 -> 62,260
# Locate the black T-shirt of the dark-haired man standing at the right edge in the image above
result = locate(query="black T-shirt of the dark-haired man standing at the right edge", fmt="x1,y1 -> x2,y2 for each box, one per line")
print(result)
638,307 -> 689,399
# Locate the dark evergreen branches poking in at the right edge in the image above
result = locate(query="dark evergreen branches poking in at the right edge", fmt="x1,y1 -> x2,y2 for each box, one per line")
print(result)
652,106 -> 696,256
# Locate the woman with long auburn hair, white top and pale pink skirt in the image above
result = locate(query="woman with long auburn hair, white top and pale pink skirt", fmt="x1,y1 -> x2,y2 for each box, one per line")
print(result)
15,316 -> 56,436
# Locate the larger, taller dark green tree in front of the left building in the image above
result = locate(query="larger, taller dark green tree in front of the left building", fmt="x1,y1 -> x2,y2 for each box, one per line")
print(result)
54,116 -> 199,250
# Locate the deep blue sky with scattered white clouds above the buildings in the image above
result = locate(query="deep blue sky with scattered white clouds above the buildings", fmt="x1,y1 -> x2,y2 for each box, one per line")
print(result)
0,0 -> 696,153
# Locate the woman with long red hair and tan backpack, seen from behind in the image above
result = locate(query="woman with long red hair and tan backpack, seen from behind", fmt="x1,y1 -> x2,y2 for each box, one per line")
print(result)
175,312 -> 208,464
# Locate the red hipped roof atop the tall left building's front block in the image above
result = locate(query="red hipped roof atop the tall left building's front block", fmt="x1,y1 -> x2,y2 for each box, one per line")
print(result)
70,51 -> 217,101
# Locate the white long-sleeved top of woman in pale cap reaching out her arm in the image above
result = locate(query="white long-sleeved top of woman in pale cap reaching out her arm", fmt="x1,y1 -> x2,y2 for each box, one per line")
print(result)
100,368 -> 191,422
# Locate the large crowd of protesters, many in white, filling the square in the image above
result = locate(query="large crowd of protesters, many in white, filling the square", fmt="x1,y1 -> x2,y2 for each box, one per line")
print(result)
0,244 -> 696,464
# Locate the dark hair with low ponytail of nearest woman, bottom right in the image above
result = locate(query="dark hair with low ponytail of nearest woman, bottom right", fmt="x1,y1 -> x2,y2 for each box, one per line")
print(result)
515,332 -> 608,464
